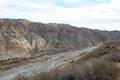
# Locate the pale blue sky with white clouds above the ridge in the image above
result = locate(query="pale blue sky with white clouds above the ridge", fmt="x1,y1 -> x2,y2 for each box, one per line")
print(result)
0,0 -> 120,30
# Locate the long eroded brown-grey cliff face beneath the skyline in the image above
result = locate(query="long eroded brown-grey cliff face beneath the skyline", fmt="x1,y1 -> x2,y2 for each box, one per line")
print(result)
0,19 -> 120,59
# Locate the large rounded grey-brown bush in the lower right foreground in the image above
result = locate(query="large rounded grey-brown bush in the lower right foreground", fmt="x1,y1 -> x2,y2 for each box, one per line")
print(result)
73,59 -> 120,80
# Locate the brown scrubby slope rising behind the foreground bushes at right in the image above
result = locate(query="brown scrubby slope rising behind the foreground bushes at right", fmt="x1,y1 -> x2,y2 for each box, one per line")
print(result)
78,42 -> 120,62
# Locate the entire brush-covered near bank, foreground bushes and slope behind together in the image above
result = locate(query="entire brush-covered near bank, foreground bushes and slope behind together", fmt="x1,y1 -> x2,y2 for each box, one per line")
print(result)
14,43 -> 120,80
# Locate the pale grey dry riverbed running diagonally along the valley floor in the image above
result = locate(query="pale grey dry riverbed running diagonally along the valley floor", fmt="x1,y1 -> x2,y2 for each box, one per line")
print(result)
0,46 -> 97,80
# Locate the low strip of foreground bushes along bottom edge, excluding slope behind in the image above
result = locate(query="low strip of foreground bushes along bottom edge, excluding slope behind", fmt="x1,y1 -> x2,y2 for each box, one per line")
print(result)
14,59 -> 120,80
